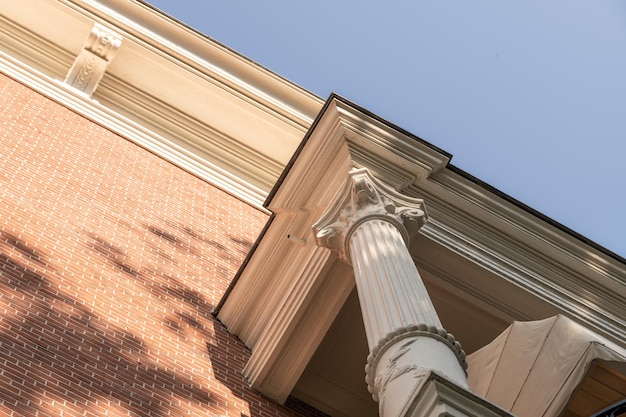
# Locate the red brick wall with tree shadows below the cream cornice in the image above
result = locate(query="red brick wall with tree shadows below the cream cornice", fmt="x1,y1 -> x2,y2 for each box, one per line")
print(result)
0,74 -> 330,417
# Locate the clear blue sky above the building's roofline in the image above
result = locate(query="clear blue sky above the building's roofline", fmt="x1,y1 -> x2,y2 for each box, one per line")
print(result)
148,0 -> 626,257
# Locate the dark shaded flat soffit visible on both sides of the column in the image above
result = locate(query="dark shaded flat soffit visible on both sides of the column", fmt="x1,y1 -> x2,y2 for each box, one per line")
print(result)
291,235 -> 558,417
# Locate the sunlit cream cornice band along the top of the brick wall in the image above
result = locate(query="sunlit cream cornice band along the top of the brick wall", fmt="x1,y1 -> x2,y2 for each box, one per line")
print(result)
0,0 -> 323,207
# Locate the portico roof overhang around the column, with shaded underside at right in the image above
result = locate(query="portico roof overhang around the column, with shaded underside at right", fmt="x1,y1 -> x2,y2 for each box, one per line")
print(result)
217,95 -> 626,415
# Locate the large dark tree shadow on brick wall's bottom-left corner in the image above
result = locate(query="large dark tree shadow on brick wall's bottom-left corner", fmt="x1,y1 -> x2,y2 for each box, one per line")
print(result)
0,233 -> 224,416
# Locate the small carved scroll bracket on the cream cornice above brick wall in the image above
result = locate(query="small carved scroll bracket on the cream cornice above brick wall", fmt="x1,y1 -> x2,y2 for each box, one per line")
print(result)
65,23 -> 122,96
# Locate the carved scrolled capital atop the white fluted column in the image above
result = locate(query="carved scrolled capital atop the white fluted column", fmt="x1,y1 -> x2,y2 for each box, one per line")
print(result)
313,168 -> 427,263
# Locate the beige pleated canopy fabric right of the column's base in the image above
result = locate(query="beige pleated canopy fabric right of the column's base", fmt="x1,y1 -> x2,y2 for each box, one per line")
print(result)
467,315 -> 626,417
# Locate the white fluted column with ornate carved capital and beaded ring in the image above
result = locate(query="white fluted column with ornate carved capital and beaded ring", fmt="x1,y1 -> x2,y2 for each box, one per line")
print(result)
314,169 -> 467,417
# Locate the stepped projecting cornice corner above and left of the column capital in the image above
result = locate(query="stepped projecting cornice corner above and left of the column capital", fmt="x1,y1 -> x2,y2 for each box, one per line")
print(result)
218,96 -> 448,402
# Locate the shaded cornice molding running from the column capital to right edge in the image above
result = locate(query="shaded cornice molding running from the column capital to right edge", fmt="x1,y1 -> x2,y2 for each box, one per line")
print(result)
410,170 -> 626,344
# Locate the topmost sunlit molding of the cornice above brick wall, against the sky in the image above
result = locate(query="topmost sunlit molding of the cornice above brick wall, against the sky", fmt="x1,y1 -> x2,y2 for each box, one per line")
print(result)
59,0 -> 322,130
